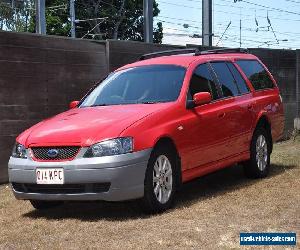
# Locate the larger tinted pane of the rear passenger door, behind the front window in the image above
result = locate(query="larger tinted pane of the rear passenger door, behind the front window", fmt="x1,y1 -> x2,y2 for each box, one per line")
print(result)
211,62 -> 239,97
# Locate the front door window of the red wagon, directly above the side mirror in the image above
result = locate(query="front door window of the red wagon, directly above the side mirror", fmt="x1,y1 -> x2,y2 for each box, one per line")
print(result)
188,64 -> 218,100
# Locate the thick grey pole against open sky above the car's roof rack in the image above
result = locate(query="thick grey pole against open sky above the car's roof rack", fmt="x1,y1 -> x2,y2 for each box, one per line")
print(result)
202,0 -> 213,46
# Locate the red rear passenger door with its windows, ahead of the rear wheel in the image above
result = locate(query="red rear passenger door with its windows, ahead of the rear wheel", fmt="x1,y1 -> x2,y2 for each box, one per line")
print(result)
211,61 -> 255,157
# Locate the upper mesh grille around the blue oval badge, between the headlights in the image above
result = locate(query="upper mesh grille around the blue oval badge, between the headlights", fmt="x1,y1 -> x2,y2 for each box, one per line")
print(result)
31,146 -> 80,161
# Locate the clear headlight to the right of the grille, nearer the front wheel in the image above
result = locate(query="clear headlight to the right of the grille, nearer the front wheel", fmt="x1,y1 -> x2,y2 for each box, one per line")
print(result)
84,137 -> 133,157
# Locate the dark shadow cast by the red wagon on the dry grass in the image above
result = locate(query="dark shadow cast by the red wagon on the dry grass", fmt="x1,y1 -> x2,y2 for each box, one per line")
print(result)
23,164 -> 296,221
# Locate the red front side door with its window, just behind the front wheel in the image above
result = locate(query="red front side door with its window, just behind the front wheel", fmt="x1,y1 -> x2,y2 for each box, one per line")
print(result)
185,63 -> 228,169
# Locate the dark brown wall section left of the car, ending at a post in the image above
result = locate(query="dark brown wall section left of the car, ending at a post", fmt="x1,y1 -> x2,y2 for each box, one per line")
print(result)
0,32 -> 108,183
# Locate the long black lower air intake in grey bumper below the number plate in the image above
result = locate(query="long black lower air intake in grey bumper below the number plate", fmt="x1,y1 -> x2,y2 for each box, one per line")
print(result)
12,183 -> 110,194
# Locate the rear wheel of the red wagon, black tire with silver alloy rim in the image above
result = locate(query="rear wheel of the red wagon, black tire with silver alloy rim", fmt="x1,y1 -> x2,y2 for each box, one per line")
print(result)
244,128 -> 272,178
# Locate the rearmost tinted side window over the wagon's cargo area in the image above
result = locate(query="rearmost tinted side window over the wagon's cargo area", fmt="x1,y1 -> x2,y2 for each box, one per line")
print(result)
236,60 -> 274,90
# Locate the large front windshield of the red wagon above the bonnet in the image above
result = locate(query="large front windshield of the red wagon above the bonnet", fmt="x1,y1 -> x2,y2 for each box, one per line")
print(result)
80,65 -> 186,107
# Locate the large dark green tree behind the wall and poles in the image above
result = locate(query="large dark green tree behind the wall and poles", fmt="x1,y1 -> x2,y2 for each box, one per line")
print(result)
30,0 -> 163,43
